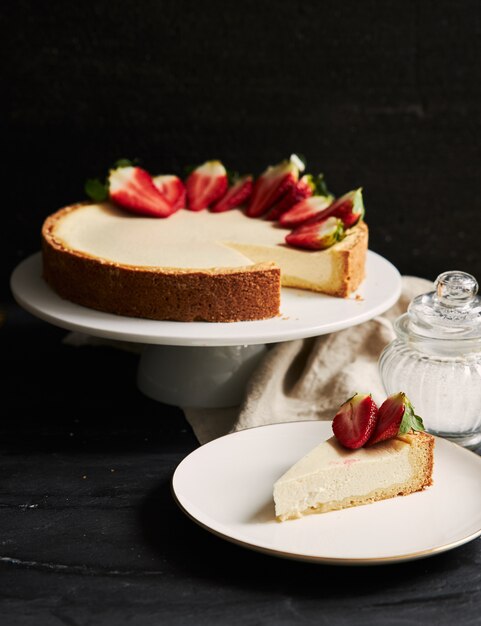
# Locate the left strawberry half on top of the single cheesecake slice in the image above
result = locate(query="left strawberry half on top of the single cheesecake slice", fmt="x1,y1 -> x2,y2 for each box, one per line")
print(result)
332,393 -> 378,450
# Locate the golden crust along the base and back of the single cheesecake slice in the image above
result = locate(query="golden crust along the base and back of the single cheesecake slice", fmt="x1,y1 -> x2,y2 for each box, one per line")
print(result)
274,431 -> 435,522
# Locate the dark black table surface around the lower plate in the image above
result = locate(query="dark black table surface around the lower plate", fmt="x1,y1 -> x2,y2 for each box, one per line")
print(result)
0,301 -> 481,626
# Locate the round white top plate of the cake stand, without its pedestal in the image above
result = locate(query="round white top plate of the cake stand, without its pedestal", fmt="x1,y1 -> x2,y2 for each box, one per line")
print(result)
11,251 -> 401,346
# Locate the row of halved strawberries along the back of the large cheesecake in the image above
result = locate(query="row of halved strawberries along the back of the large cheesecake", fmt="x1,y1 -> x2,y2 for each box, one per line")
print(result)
85,154 -> 365,250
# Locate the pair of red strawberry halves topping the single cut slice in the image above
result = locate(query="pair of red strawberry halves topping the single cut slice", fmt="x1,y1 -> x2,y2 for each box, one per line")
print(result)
332,391 -> 424,450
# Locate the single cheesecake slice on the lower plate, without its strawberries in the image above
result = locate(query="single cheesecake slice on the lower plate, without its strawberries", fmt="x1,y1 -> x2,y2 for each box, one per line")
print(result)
273,431 -> 434,521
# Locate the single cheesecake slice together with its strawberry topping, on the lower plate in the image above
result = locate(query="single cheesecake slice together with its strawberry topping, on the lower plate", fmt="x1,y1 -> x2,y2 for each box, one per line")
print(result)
273,392 -> 434,521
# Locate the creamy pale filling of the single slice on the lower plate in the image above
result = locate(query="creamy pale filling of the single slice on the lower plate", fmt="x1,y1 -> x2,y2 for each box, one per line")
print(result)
274,438 -> 412,517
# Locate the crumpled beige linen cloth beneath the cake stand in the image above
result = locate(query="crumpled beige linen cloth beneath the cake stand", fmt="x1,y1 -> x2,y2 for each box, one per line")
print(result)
65,276 -> 434,444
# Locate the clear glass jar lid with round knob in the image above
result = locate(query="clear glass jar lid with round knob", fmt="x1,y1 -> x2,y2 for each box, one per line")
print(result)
404,271 -> 481,340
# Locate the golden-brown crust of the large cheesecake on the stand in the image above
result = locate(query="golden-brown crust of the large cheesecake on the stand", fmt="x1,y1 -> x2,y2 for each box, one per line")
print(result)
41,202 -> 368,322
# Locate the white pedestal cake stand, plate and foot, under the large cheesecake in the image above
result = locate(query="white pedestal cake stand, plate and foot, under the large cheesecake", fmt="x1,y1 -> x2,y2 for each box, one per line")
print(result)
11,251 -> 401,408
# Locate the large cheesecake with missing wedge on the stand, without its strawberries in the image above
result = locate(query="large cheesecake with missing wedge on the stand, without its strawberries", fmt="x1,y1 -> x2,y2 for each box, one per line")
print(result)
42,203 -> 368,322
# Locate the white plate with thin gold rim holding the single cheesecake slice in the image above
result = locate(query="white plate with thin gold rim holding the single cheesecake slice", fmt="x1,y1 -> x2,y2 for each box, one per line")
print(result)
172,421 -> 481,565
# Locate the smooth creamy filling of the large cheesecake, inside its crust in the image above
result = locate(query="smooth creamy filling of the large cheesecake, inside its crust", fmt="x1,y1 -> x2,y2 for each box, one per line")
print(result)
53,204 -> 348,284
